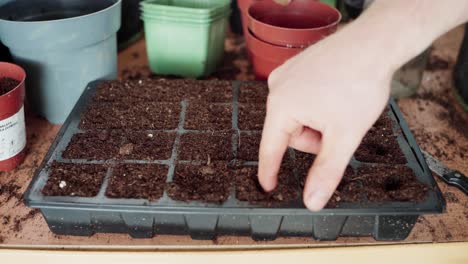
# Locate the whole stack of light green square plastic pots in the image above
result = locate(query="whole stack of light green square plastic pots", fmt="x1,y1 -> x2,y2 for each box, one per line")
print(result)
141,0 -> 231,78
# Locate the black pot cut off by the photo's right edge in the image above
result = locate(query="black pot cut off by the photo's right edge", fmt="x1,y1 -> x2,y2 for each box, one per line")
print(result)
453,24 -> 468,108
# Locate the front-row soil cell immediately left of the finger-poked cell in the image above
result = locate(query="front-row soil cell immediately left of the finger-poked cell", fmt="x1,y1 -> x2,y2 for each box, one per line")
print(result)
167,162 -> 232,203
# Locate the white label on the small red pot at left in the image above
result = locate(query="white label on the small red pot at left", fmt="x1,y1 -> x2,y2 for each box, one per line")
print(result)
0,106 -> 26,161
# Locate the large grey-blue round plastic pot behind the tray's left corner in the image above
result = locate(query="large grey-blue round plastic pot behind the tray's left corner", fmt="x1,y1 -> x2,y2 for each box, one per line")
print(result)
0,0 -> 121,124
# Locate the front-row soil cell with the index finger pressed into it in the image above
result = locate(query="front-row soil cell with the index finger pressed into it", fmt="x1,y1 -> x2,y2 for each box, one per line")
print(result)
236,167 -> 301,206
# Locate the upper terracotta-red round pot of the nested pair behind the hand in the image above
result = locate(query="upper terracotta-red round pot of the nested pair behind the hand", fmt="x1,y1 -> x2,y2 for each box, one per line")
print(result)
247,0 -> 341,47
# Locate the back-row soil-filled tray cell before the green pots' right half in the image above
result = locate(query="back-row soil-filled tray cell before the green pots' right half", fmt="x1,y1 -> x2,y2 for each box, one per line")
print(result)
184,80 -> 232,103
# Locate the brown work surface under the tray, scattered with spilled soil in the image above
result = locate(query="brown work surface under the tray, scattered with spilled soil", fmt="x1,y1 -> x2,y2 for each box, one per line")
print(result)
0,28 -> 468,248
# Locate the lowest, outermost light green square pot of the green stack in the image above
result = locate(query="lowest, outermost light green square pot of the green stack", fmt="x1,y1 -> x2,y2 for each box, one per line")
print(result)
143,12 -> 228,78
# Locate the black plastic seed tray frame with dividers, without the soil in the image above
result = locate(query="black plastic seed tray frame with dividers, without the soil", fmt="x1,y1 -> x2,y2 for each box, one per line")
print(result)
25,82 -> 445,240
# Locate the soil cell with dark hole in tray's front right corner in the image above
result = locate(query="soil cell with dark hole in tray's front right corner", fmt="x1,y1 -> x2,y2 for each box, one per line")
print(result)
352,166 -> 428,203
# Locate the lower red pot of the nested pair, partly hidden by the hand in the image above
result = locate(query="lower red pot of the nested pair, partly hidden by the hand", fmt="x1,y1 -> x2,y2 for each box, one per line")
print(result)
246,31 -> 304,80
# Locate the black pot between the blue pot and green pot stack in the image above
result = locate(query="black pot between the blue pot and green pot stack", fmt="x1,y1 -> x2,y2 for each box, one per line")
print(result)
117,0 -> 143,50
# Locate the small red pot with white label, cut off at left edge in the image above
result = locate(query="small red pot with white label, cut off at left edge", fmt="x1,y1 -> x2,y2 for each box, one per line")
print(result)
0,62 -> 26,171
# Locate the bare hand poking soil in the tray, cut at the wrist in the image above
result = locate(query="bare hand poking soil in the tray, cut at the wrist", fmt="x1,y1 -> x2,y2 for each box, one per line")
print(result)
259,21 -> 397,211
